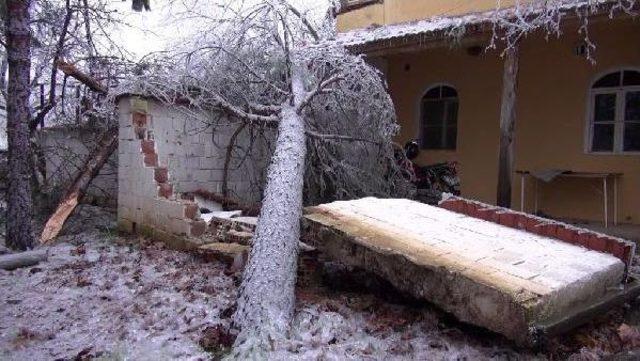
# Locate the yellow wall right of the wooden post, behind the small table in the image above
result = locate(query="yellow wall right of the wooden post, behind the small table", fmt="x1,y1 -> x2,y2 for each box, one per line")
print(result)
514,20 -> 640,224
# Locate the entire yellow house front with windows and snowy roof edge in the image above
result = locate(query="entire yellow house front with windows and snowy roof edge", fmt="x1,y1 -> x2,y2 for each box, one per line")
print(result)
338,0 -> 640,224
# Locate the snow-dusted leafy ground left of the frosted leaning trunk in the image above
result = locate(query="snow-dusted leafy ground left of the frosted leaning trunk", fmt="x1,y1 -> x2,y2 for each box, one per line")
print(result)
0,236 -> 235,361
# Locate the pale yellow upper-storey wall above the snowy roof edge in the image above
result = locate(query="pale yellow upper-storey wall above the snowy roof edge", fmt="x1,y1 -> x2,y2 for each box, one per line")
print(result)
337,0 -> 514,31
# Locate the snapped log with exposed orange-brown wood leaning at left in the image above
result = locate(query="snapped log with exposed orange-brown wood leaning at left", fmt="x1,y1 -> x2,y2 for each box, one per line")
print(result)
40,127 -> 118,244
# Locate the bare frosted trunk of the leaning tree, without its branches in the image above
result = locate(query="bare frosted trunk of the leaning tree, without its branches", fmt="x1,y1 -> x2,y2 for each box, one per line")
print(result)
234,72 -> 306,353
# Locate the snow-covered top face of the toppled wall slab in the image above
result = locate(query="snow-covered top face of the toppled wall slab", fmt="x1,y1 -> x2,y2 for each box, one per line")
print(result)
321,198 -> 624,295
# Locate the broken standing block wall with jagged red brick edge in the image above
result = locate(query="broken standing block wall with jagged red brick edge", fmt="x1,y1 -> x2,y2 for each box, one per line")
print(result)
118,97 -> 269,241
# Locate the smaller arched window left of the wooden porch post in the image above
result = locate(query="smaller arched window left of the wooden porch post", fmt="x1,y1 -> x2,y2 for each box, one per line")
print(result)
420,85 -> 458,149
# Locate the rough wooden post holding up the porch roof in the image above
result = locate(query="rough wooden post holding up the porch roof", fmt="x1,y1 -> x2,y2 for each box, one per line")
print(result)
497,44 -> 519,208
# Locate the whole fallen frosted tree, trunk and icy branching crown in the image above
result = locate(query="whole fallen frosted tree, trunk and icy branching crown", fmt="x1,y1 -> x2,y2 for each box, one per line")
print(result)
128,0 -> 406,359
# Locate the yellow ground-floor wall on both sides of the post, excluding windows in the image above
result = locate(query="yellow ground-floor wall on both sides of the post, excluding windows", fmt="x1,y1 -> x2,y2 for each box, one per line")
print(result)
387,20 -> 640,224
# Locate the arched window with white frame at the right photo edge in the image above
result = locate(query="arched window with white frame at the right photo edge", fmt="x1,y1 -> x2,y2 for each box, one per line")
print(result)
589,70 -> 640,153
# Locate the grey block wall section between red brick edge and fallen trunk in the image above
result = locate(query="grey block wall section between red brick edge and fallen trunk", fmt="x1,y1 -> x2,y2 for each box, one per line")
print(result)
142,101 -> 269,202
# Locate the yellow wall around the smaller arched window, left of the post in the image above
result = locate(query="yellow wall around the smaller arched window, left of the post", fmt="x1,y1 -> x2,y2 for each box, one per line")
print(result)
387,40 -> 502,203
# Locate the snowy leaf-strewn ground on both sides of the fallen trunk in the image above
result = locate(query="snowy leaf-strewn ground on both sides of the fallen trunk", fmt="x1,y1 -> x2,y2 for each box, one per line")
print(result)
0,207 -> 640,360
